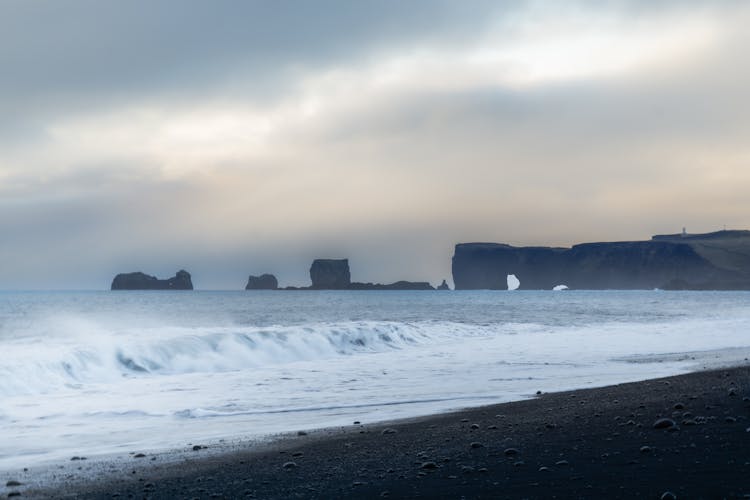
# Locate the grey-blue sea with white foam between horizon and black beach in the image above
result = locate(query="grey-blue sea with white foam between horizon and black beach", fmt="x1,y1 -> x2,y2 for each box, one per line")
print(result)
0,291 -> 750,470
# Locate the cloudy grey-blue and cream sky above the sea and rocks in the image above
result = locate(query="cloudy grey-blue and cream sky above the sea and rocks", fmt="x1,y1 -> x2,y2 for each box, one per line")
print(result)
0,0 -> 750,289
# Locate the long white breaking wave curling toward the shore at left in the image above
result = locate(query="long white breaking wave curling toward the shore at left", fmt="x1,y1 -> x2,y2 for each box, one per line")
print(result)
0,321 -> 516,396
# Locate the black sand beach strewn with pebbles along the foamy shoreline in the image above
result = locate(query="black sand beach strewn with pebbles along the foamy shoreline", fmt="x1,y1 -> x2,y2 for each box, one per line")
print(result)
11,367 -> 750,499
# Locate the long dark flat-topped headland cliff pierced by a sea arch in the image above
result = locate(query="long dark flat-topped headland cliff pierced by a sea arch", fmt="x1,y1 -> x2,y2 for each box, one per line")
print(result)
453,231 -> 750,290
